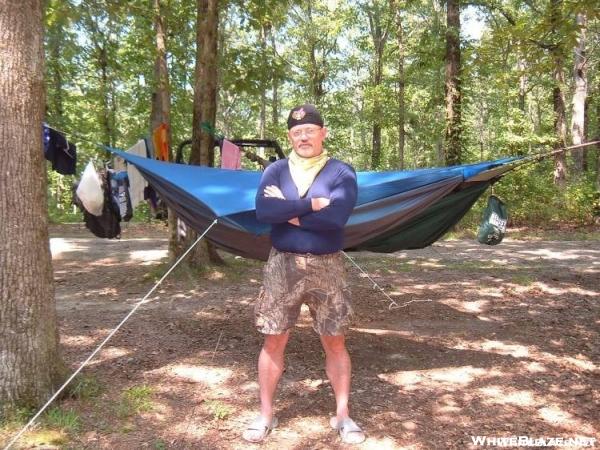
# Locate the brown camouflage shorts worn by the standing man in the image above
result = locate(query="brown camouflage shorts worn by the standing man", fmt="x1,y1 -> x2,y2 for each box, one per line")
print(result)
254,248 -> 352,336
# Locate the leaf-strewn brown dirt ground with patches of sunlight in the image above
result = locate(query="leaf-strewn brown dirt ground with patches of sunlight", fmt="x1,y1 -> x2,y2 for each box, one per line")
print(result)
10,225 -> 600,449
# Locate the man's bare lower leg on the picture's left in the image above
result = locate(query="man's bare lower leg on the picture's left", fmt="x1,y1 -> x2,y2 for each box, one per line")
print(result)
258,332 -> 290,422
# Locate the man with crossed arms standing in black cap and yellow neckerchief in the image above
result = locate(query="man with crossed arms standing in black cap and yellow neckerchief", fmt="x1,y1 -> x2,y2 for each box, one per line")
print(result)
243,104 -> 365,443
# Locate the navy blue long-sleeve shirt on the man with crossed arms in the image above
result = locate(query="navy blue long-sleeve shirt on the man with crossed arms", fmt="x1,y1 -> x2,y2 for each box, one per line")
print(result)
256,159 -> 358,255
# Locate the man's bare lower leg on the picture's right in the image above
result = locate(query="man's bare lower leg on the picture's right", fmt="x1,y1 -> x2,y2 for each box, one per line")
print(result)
321,335 -> 352,423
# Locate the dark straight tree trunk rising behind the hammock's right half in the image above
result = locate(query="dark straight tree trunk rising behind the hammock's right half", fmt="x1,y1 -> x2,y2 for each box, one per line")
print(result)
445,0 -> 461,166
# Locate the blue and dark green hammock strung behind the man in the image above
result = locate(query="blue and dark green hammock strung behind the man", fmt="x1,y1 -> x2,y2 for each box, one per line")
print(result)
111,149 -> 521,260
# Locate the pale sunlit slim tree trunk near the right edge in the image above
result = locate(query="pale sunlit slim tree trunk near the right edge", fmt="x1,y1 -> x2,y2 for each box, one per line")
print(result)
571,14 -> 587,176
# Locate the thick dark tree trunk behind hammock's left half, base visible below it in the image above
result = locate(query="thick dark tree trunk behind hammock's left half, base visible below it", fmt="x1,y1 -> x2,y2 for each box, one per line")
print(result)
188,0 -> 223,267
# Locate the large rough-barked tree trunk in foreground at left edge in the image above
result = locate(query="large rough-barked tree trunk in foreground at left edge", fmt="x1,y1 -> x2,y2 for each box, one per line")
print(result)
0,0 -> 64,416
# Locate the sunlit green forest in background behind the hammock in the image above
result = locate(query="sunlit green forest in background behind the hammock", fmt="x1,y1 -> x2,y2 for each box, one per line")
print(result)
45,0 -> 600,226
